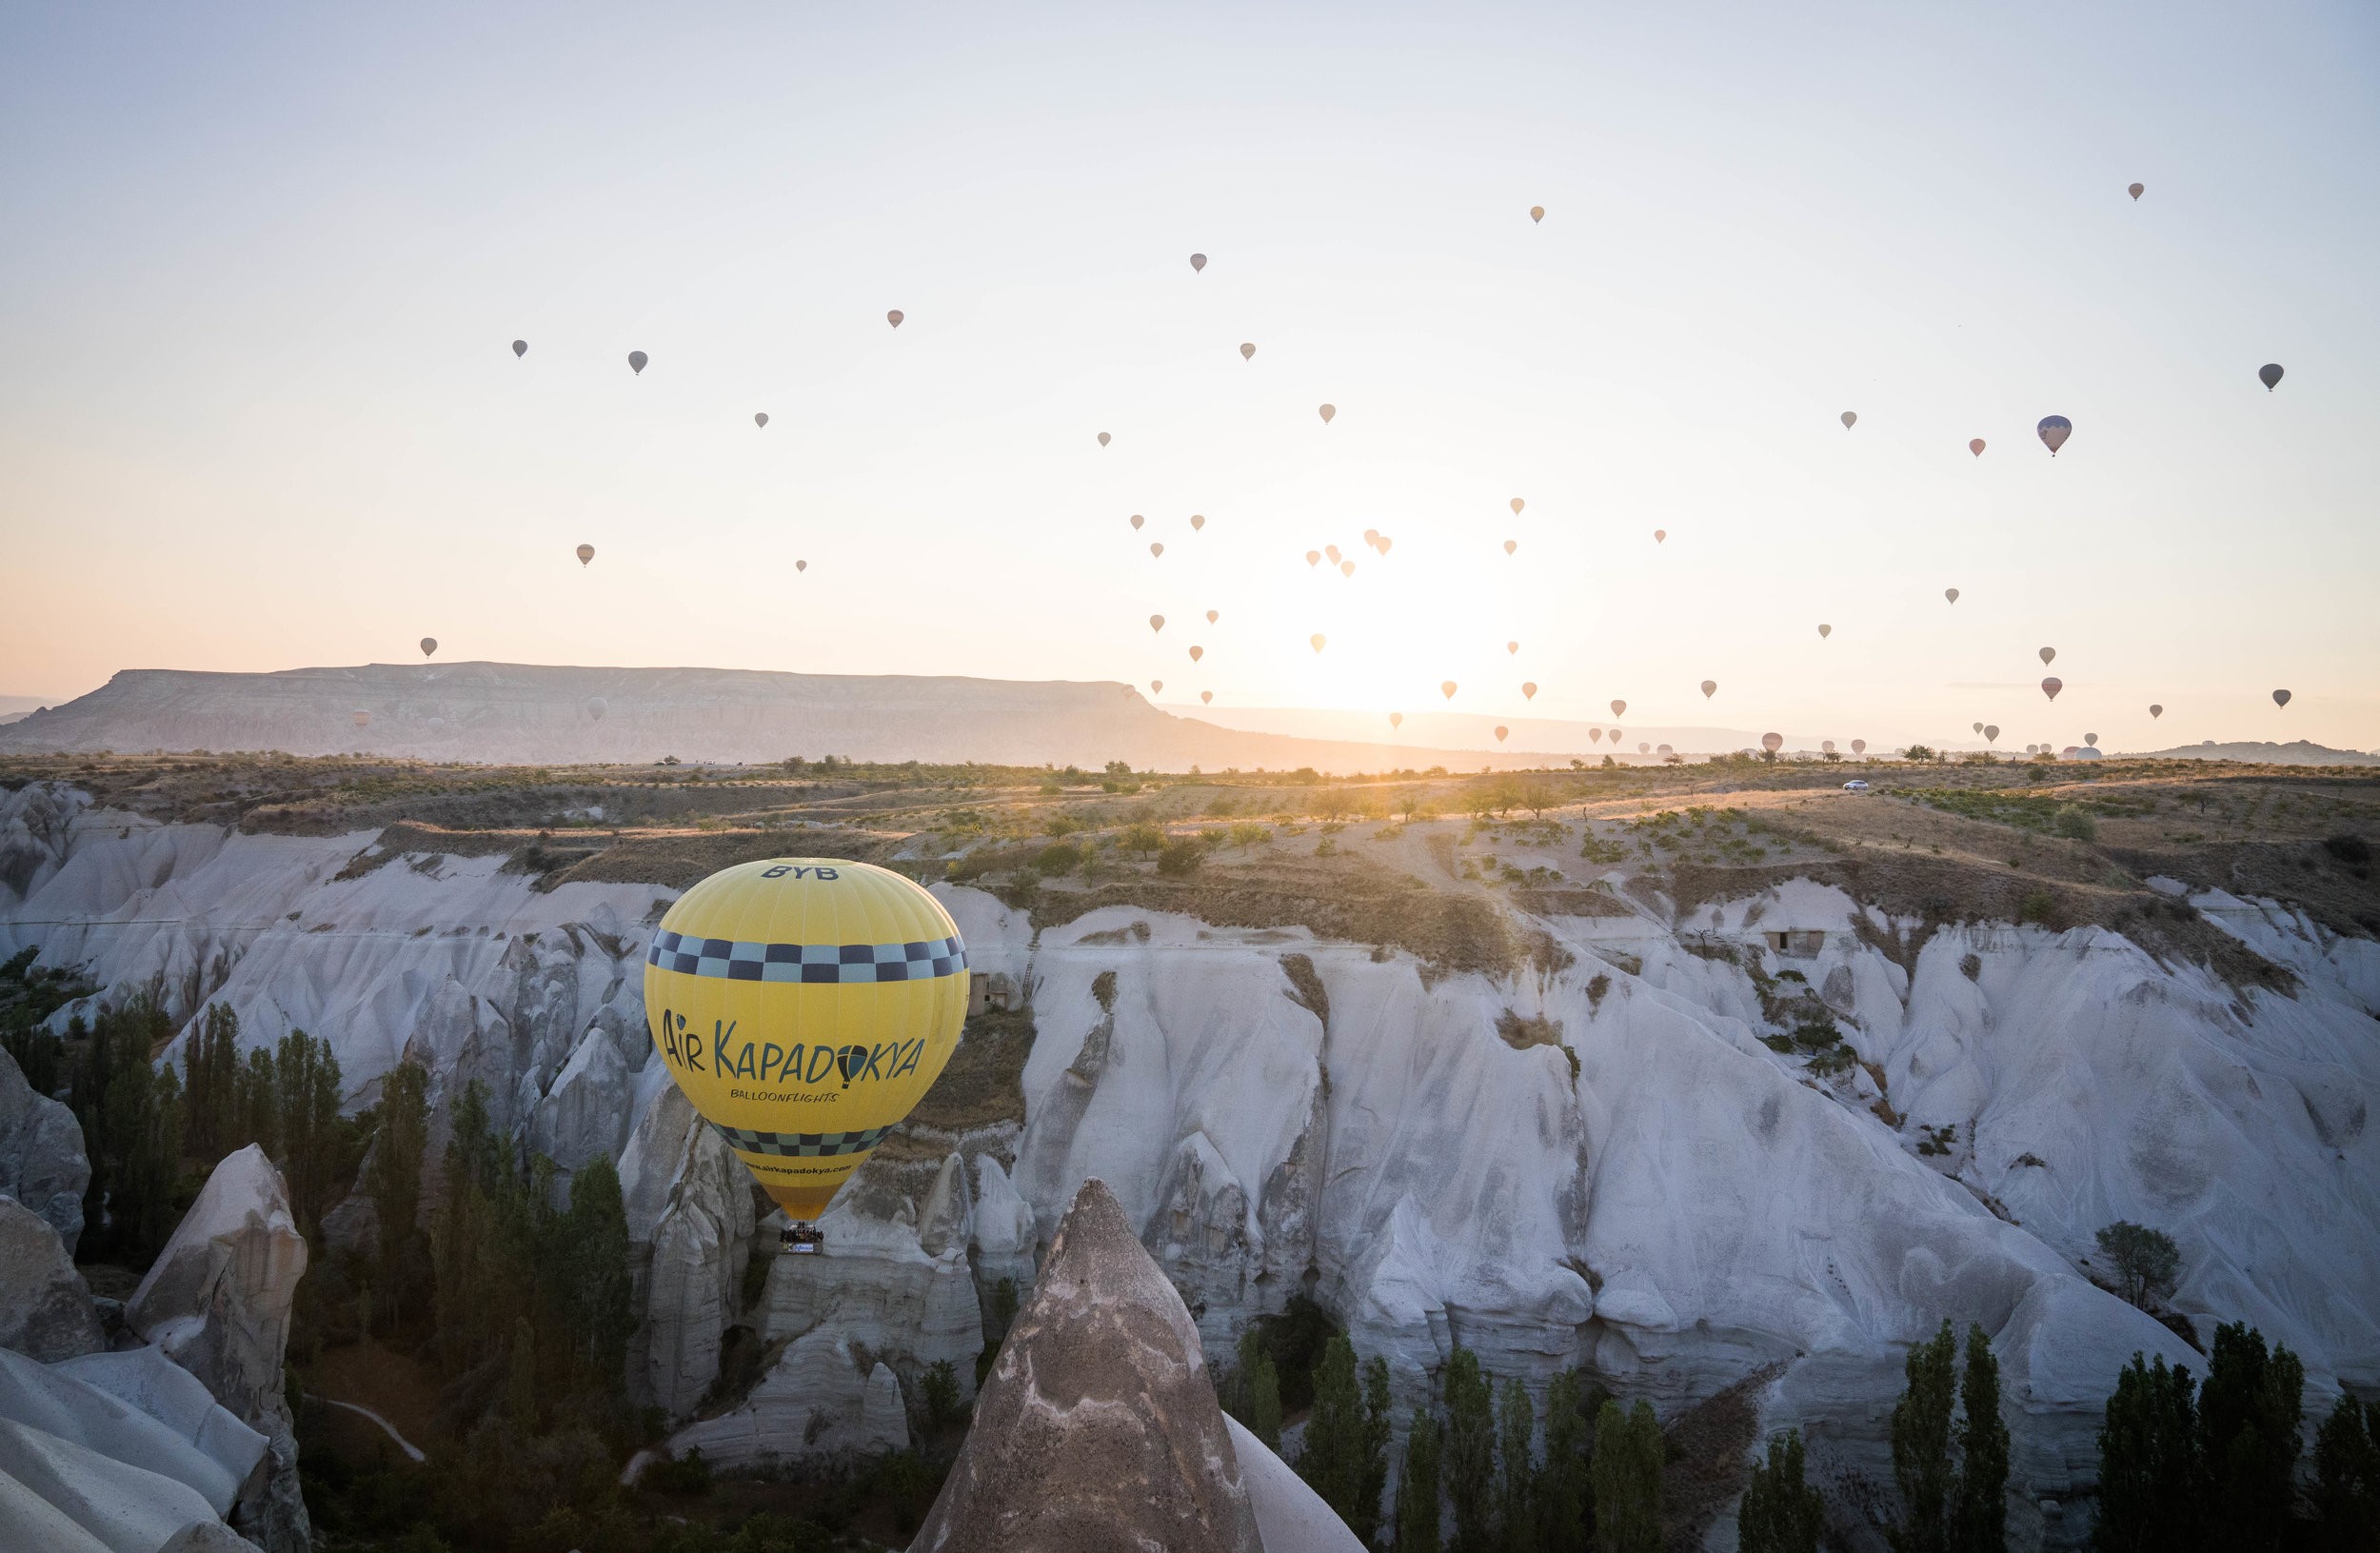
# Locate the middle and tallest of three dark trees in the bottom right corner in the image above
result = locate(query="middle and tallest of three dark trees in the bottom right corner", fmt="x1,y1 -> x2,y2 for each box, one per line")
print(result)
2199,1322 -> 2307,1553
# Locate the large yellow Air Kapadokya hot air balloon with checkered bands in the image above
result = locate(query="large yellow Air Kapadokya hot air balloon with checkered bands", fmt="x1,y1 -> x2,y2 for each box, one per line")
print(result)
645,858 -> 966,1250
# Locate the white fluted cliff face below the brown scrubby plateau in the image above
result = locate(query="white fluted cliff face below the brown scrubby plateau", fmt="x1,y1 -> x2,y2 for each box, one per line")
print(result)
0,786 -> 2380,1545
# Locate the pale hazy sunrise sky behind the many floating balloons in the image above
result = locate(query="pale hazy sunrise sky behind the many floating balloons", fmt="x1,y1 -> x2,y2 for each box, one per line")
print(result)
0,0 -> 2380,747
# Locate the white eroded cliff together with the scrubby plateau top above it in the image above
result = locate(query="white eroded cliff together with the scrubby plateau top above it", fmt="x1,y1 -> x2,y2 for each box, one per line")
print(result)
0,762 -> 2380,1545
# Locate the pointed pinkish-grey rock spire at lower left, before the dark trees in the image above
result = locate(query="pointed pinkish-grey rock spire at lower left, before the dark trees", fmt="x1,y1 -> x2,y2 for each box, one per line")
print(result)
124,1144 -> 309,1553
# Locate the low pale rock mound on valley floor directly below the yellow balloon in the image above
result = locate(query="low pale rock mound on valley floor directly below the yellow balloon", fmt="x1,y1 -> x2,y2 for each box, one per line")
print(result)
669,1329 -> 909,1467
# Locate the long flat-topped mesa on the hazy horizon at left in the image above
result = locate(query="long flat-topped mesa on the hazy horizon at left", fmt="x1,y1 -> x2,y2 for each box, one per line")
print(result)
0,662 -> 1599,771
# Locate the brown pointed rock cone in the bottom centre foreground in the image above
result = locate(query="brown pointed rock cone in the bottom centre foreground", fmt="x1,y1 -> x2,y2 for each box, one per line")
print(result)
912,1179 -> 1264,1553
